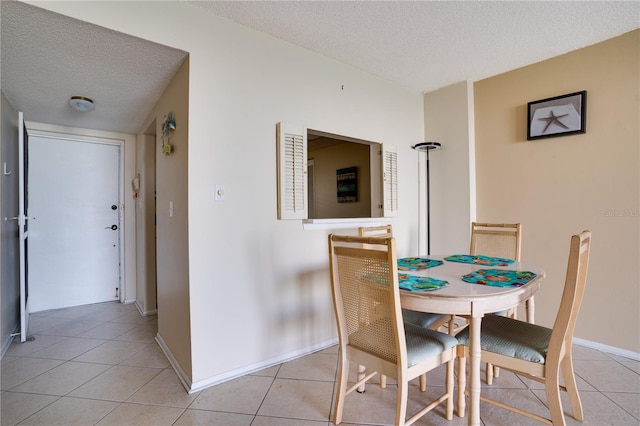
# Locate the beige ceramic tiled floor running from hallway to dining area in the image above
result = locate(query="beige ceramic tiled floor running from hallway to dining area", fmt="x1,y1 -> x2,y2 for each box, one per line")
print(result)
1,303 -> 640,426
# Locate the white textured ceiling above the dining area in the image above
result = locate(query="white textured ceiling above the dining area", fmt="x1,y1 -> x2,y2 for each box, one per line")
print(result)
187,1 -> 640,92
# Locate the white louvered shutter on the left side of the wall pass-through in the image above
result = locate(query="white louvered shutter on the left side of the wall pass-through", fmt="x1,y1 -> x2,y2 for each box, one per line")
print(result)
276,123 -> 307,219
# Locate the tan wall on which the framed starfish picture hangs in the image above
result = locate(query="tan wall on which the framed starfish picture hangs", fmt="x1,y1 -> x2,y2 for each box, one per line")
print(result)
475,30 -> 640,353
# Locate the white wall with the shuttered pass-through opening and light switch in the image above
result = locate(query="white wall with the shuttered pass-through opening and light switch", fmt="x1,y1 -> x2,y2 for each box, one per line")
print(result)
35,2 -> 424,388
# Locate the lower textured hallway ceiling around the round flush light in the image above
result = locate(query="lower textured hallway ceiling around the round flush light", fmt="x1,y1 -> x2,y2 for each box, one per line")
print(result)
0,1 -> 187,133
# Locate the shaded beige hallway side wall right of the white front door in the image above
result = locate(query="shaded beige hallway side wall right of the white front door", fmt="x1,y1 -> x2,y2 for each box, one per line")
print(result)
136,57 -> 193,385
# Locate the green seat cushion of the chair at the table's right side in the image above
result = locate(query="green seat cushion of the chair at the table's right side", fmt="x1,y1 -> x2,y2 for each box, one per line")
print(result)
456,315 -> 551,364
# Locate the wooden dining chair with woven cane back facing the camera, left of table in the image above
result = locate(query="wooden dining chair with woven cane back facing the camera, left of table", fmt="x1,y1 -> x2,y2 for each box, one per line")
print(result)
329,234 -> 458,425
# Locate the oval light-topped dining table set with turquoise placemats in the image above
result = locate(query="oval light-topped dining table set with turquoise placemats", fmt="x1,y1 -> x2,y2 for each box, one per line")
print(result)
398,255 -> 545,425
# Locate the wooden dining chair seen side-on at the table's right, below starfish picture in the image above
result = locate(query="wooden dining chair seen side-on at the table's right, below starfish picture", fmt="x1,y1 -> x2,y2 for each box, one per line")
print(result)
456,231 -> 591,425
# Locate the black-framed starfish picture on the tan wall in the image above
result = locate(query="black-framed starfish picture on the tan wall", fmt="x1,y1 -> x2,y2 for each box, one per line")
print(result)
527,90 -> 587,140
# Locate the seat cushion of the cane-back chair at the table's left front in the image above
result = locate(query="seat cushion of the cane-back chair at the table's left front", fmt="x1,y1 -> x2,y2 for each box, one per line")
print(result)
404,323 -> 458,367
